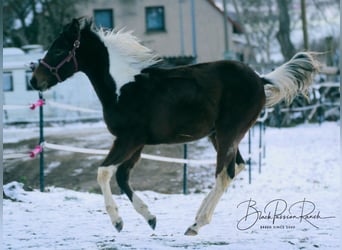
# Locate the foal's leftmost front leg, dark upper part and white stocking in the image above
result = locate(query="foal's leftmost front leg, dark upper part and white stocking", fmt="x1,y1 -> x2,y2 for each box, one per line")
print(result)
97,140 -> 142,232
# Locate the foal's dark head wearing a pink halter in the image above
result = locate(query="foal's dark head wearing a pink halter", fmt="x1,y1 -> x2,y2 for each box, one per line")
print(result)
30,19 -> 80,91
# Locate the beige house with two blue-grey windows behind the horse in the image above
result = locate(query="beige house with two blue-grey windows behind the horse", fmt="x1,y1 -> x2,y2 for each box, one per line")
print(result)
77,0 -> 246,62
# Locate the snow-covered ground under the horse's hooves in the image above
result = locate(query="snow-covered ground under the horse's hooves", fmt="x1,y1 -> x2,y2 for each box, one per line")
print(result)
2,122 -> 341,250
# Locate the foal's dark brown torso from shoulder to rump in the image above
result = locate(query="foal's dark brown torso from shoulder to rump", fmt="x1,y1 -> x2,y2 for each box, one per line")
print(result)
119,61 -> 264,144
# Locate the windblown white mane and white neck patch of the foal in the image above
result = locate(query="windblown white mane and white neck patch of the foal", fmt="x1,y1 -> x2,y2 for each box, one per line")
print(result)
96,28 -> 160,92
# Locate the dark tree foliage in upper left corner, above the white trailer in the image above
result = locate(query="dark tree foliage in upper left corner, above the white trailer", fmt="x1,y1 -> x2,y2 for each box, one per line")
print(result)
3,0 -> 86,47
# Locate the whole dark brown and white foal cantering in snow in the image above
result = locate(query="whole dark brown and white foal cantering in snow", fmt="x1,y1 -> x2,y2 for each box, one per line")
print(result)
30,19 -> 319,235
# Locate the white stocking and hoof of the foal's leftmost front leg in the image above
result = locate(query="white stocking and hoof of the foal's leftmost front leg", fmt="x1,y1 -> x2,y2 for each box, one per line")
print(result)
97,166 -> 122,231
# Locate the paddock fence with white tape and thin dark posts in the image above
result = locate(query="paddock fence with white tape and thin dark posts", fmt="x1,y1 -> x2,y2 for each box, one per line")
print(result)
3,80 -> 339,194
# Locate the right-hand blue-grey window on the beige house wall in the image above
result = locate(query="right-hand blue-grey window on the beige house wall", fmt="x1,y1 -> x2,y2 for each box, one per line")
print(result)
145,6 -> 165,32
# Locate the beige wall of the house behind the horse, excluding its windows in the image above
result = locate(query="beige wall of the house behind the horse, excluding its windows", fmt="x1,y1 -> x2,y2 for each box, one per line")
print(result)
78,0 -> 233,62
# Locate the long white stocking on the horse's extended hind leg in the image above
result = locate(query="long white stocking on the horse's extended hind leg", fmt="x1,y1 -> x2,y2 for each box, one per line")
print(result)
185,164 -> 244,235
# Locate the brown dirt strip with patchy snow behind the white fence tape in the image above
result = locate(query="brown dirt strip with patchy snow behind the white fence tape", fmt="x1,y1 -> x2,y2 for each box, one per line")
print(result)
3,126 -> 219,194
